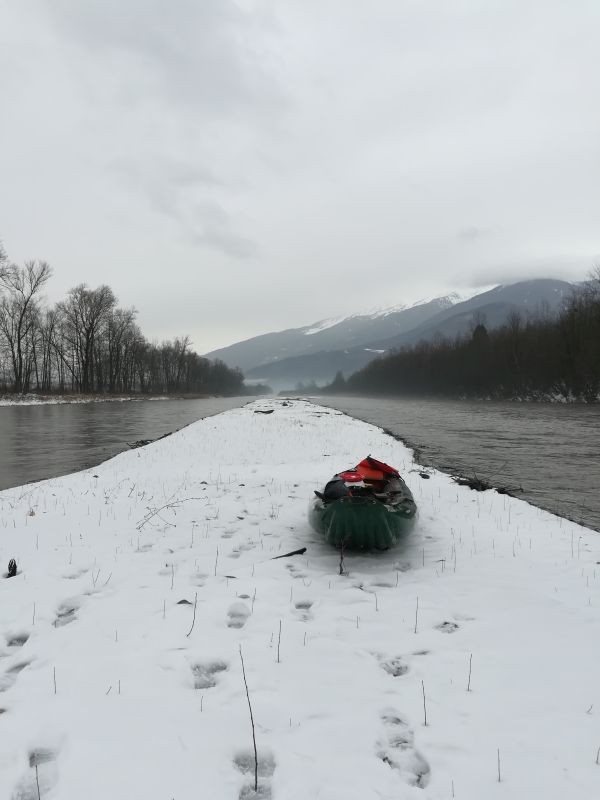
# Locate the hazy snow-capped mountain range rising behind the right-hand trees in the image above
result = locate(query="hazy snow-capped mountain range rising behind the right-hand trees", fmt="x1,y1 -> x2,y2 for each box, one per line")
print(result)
207,279 -> 573,387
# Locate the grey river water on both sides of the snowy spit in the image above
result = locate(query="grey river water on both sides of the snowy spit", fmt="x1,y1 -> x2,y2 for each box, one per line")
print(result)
0,397 -> 600,530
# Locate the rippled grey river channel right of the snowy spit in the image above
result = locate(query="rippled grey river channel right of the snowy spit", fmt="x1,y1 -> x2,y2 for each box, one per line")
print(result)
316,397 -> 600,530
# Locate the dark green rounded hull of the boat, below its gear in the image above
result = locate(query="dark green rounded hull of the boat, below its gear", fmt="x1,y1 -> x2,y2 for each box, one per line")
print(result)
309,497 -> 416,550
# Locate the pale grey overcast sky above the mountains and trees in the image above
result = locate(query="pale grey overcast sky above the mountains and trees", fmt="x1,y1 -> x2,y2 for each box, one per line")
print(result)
0,0 -> 600,352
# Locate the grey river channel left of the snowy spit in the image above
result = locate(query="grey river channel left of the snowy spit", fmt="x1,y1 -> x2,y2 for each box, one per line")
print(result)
0,397 -> 251,489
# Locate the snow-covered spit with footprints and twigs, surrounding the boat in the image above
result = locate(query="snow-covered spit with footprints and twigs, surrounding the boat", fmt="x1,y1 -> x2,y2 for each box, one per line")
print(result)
0,400 -> 600,800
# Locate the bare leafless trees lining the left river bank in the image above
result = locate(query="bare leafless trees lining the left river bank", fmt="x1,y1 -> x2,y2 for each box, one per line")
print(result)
0,243 -> 246,395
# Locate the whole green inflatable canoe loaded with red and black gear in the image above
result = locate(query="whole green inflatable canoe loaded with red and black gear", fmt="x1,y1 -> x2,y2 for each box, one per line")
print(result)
309,456 -> 417,550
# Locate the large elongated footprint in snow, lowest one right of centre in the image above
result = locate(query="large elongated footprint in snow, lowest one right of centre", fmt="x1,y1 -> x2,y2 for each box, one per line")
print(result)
377,709 -> 431,789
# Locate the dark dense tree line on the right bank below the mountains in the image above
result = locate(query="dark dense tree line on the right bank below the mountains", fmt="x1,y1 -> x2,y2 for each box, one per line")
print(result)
327,274 -> 600,402
